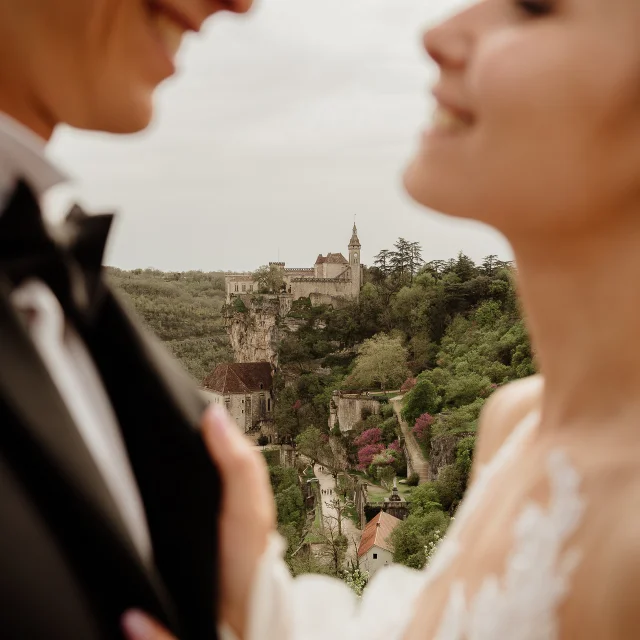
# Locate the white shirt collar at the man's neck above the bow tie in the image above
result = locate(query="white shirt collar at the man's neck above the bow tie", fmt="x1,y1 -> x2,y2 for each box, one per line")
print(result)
0,111 -> 67,213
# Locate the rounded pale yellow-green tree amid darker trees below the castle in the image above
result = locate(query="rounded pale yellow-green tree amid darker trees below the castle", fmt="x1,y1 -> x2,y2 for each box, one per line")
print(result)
346,333 -> 411,391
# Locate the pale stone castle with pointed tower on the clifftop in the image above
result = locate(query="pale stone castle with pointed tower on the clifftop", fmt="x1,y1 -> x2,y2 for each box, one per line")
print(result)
225,224 -> 362,304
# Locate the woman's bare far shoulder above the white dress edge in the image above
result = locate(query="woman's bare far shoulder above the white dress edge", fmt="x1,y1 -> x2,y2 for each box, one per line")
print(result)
474,375 -> 544,476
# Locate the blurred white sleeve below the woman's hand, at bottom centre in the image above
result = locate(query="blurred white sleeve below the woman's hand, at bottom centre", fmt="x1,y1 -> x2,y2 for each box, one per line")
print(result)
220,535 -> 425,640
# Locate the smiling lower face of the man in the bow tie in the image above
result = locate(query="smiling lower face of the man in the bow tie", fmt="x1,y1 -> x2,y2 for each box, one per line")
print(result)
0,0 -> 252,133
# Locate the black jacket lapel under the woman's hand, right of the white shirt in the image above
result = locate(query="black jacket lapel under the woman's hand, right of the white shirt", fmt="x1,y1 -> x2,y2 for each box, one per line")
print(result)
84,287 -> 221,640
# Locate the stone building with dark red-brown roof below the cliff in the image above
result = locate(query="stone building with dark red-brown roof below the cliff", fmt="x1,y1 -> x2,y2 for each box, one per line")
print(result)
203,362 -> 273,433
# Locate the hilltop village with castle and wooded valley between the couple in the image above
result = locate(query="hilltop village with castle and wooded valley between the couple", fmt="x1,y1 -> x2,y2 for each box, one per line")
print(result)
111,242 -> 524,592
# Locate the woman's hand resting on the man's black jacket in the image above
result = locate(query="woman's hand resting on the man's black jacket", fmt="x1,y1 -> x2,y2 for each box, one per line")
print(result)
123,406 -> 276,640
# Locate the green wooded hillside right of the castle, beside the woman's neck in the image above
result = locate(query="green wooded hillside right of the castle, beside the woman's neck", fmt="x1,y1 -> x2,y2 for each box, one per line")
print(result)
262,245 -> 535,568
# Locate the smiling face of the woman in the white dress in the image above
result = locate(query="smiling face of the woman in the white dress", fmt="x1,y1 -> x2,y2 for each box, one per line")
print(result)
405,0 -> 640,240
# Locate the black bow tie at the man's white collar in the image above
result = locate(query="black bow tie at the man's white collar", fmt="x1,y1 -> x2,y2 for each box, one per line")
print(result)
0,181 -> 113,323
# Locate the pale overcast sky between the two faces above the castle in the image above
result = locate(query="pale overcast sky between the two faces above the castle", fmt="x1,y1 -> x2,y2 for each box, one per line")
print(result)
50,0 -> 510,271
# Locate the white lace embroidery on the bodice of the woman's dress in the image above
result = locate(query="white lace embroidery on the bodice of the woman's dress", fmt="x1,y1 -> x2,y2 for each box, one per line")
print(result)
412,413 -> 585,640
